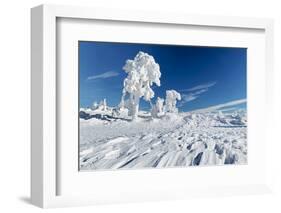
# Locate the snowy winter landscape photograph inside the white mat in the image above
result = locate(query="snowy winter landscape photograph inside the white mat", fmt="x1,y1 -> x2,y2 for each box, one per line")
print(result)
77,41 -> 248,171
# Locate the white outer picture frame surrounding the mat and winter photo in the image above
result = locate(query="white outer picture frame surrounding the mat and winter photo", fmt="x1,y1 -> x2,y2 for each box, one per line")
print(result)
31,5 -> 273,208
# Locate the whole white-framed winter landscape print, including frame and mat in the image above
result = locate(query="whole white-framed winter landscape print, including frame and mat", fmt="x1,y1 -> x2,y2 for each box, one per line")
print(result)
31,5 -> 273,207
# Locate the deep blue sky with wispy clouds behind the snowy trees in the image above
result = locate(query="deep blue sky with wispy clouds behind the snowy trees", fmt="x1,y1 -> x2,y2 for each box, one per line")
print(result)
79,41 -> 247,111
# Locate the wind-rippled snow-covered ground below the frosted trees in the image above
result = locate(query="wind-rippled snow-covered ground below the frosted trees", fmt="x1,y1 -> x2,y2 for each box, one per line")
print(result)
80,111 -> 247,170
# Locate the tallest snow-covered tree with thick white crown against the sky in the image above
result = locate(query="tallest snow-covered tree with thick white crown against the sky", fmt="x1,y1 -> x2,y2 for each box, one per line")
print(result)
121,51 -> 161,120
